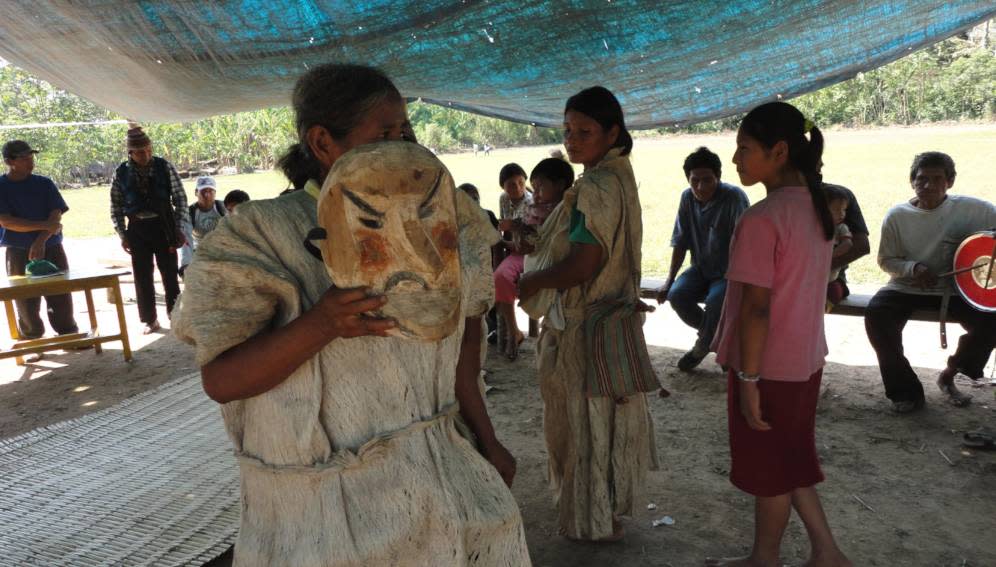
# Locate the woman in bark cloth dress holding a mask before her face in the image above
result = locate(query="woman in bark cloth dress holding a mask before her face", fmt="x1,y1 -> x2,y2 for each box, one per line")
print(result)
174,64 -> 529,567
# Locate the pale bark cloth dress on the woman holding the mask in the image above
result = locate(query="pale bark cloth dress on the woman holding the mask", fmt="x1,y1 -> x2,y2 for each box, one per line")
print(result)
173,190 -> 530,567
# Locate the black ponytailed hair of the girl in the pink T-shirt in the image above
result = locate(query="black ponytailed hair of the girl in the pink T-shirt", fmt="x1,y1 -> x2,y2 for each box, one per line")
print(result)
740,102 -> 835,240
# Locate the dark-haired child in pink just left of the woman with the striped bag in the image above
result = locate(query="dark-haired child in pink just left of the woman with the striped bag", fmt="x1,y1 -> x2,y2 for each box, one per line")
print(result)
495,158 -> 574,360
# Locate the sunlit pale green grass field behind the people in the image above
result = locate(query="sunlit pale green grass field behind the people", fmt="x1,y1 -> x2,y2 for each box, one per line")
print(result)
58,124 -> 996,284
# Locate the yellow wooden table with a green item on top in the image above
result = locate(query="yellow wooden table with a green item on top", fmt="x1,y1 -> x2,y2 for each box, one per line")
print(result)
0,268 -> 131,364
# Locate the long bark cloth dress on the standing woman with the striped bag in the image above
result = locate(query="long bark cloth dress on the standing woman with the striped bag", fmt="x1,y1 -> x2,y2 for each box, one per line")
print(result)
537,149 -> 657,539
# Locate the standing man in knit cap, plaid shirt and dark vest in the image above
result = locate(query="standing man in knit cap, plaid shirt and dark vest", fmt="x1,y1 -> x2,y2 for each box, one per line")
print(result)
111,125 -> 189,335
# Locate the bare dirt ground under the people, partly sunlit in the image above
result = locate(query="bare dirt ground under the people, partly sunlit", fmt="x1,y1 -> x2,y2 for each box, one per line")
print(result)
0,242 -> 996,567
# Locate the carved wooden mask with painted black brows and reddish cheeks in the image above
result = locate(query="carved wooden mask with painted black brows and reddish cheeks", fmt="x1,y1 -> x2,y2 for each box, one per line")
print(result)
318,142 -> 461,341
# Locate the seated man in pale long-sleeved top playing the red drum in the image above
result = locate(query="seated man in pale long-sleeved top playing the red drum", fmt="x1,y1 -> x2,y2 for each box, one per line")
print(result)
865,152 -> 996,413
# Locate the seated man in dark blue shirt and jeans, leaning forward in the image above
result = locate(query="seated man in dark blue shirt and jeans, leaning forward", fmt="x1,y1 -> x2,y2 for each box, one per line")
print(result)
657,147 -> 750,371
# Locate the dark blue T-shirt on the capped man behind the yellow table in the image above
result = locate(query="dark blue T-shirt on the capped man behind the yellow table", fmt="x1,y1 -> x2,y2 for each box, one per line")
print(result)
0,174 -> 69,248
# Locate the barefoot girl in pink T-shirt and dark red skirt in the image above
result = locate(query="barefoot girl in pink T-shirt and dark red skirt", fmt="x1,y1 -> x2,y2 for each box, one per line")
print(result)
707,102 -> 851,566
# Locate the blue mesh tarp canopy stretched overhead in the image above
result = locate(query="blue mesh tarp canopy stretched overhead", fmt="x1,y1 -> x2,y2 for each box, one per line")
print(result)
0,0 -> 996,128
